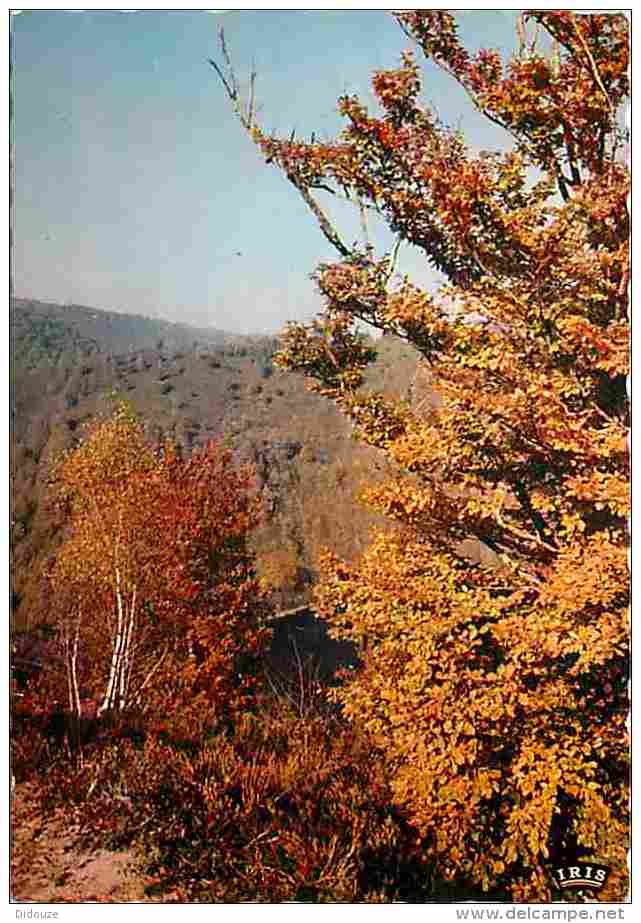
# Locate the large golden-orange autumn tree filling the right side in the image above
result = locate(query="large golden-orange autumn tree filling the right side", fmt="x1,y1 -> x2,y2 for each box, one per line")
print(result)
212,10 -> 629,901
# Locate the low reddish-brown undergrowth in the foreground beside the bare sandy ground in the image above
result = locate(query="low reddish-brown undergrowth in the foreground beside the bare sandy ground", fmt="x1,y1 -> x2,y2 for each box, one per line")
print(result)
37,701 -> 435,903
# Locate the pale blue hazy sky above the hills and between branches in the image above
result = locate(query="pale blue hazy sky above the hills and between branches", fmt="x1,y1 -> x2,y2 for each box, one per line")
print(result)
11,10 -> 516,333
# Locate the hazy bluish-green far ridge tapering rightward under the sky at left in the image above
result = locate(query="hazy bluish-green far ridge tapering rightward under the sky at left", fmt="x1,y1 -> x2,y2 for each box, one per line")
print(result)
9,298 -> 231,367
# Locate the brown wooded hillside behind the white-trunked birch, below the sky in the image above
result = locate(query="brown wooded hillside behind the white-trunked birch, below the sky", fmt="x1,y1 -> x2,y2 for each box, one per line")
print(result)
10,299 -> 415,626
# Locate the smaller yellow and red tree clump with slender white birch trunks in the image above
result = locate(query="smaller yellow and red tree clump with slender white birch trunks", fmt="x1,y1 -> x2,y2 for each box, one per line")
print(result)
50,405 -> 264,716
